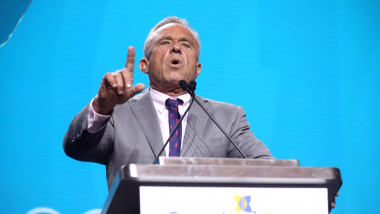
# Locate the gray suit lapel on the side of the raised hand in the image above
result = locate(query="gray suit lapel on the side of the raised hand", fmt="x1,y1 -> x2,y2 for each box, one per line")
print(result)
131,90 -> 165,157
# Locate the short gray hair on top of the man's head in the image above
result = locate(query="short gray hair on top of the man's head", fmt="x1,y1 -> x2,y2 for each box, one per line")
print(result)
144,16 -> 201,59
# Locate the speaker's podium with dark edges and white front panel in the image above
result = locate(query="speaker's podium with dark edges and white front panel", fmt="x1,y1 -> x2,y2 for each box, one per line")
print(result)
102,157 -> 342,214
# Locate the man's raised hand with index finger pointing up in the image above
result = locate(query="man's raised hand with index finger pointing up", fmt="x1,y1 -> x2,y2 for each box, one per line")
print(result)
92,46 -> 145,115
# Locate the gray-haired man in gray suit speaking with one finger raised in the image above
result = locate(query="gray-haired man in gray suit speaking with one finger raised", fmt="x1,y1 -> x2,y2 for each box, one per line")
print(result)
63,17 -> 273,188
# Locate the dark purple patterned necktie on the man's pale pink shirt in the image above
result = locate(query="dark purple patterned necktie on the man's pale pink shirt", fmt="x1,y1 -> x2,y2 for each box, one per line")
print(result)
165,98 -> 183,157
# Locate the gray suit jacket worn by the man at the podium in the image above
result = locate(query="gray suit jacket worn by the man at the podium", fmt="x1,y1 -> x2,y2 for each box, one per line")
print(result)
63,90 -> 272,188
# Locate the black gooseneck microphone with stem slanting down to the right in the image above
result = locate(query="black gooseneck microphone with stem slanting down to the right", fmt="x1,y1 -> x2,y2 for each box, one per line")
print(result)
179,80 -> 248,158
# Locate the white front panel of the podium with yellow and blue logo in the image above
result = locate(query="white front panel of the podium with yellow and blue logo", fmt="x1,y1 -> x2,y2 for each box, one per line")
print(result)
140,186 -> 328,214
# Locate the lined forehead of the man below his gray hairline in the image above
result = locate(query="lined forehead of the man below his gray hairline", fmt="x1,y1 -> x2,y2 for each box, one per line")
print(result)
153,23 -> 196,41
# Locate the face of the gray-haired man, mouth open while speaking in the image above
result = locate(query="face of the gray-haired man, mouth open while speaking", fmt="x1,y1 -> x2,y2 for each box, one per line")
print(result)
140,24 -> 201,93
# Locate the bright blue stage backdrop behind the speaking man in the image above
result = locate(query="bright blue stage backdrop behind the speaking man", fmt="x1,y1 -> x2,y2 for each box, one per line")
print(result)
0,0 -> 380,214
